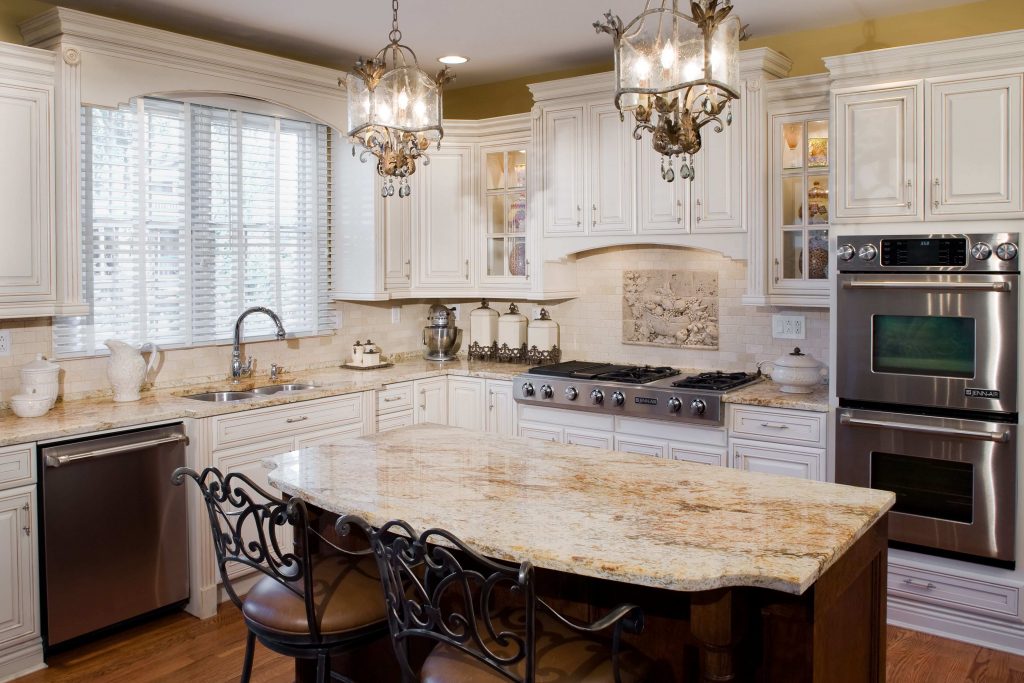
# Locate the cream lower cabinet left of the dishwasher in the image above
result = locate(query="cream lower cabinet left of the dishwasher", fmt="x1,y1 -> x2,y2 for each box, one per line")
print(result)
0,444 -> 43,680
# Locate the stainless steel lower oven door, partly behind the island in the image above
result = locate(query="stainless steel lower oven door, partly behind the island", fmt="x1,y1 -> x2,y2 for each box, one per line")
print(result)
836,409 -> 1017,562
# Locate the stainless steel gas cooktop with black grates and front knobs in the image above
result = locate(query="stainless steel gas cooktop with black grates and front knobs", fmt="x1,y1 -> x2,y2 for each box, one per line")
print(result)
515,360 -> 760,424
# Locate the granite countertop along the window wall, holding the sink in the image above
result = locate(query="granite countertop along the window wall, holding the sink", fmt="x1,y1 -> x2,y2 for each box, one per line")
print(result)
0,359 -> 526,446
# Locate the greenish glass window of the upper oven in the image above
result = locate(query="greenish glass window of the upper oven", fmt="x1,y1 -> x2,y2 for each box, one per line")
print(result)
871,315 -> 975,377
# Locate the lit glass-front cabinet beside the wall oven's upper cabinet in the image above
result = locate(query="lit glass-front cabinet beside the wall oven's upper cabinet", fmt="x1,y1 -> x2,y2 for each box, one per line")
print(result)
769,111 -> 829,296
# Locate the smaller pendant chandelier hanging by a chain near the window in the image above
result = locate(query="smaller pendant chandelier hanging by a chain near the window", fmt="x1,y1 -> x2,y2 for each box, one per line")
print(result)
347,0 -> 455,197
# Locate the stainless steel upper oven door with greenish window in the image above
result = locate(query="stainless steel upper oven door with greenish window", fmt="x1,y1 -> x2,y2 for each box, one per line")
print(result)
836,273 -> 1020,413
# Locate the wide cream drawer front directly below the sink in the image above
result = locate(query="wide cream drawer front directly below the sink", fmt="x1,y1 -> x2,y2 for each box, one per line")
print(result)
212,393 -> 362,449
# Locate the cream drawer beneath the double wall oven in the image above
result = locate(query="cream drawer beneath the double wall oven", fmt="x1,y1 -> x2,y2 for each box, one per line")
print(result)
889,562 -> 1021,621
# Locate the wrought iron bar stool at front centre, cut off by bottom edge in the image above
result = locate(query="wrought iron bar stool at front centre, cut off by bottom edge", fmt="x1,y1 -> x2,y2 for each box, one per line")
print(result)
336,515 -> 651,683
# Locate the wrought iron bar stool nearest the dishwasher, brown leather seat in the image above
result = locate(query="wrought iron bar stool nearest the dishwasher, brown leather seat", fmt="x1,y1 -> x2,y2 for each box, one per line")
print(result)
171,467 -> 387,683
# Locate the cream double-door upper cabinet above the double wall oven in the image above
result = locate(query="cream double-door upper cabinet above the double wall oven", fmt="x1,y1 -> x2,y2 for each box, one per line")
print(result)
825,31 -> 1024,222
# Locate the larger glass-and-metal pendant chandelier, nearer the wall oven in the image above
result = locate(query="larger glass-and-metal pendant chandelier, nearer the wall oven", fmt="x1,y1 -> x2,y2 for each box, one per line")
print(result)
594,0 -> 742,182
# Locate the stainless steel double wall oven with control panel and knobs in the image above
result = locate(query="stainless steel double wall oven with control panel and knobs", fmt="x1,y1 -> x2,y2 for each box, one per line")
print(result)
835,232 -> 1020,566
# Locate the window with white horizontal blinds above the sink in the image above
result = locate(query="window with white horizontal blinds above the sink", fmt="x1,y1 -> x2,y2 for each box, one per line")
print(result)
54,98 -> 334,356
